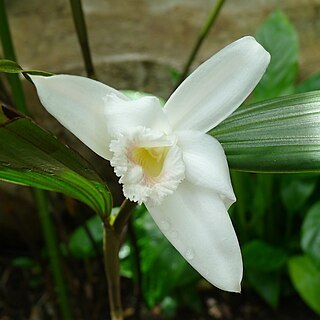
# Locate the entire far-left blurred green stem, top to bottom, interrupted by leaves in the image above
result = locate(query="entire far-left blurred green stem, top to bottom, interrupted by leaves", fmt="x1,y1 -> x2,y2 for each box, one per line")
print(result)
0,0 -> 72,320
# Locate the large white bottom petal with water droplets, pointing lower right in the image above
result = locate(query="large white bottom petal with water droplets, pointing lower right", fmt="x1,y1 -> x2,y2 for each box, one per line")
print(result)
146,181 -> 242,292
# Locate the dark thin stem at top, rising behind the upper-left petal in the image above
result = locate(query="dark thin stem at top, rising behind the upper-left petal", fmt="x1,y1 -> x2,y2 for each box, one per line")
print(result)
70,0 -> 96,78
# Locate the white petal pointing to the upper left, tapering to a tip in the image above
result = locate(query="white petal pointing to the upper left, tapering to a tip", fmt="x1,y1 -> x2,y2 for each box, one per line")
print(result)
30,75 -> 128,159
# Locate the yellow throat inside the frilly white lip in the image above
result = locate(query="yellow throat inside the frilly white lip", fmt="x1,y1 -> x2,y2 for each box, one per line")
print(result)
131,147 -> 169,178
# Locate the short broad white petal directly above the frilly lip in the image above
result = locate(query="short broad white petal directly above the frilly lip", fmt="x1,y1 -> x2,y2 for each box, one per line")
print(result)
104,95 -> 171,135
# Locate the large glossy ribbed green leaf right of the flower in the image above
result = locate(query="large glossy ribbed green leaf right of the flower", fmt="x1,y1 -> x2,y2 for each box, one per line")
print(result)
210,91 -> 320,172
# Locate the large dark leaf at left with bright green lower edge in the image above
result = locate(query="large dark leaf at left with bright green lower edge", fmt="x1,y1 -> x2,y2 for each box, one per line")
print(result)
0,108 -> 111,215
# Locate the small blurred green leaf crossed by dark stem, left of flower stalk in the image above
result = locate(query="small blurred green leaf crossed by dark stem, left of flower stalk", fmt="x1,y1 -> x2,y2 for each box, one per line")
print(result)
68,215 -> 103,259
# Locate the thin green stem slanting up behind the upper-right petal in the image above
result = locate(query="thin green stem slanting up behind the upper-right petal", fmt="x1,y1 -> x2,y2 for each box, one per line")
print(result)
176,0 -> 225,88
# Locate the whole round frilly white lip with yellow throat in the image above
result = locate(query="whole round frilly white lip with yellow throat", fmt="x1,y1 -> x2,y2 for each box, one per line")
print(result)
109,127 -> 185,205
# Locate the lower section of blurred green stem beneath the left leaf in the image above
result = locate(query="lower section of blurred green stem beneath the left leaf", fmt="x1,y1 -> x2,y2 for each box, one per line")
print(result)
33,189 -> 72,320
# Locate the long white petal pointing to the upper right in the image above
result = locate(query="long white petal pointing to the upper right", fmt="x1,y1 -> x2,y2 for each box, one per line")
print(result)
164,37 -> 270,132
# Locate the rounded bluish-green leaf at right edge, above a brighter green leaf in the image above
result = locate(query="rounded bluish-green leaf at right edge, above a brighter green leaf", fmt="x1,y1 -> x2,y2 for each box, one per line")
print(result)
301,201 -> 320,267
